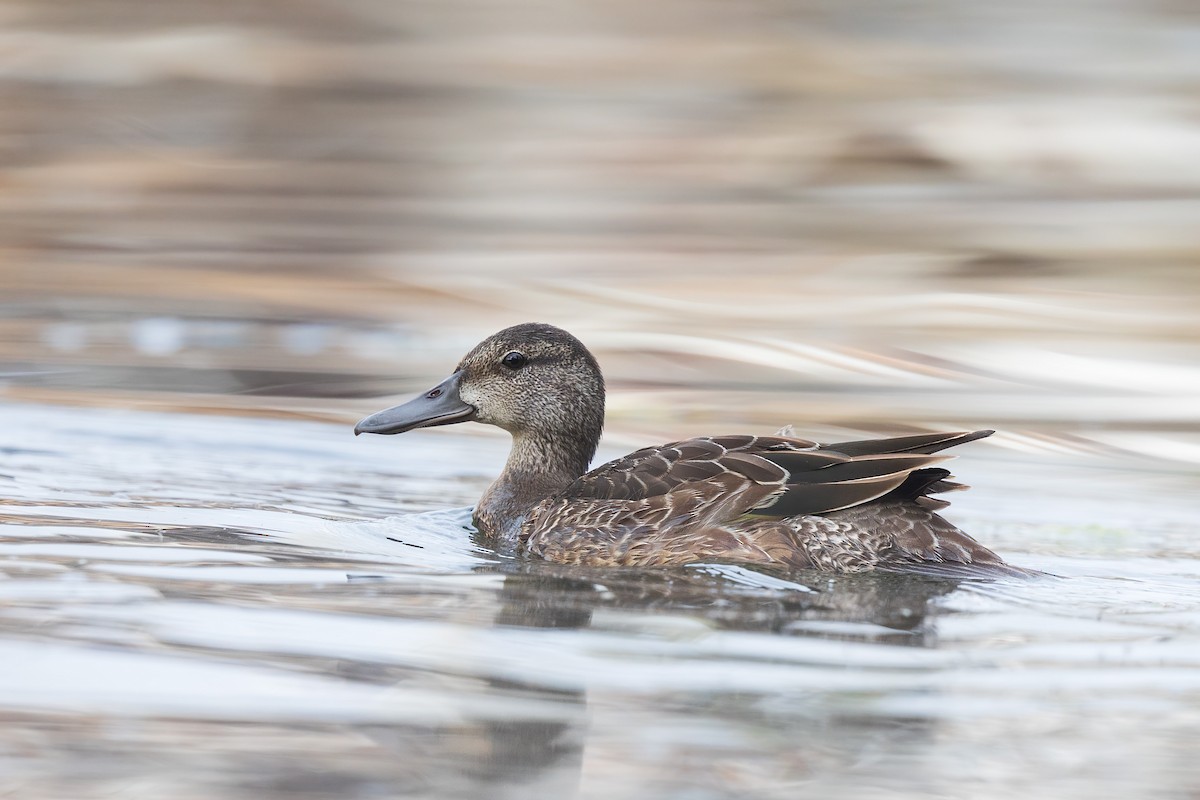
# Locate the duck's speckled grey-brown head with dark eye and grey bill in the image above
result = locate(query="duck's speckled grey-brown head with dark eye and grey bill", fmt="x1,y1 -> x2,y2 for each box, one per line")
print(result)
354,323 -> 604,456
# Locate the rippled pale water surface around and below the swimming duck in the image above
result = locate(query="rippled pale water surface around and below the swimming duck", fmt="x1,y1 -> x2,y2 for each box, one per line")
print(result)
0,404 -> 1200,799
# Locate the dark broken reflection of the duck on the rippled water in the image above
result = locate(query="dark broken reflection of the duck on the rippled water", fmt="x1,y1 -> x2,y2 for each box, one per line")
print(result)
429,560 -> 958,798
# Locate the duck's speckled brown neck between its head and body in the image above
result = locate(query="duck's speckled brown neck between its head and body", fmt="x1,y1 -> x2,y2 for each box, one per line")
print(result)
475,431 -> 600,543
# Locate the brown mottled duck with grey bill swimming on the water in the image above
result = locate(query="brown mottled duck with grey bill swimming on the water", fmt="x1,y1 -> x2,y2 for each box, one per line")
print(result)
354,323 -> 1027,578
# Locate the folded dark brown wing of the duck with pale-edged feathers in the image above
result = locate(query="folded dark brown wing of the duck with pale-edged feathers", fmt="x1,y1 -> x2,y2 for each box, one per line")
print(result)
558,435 -> 946,524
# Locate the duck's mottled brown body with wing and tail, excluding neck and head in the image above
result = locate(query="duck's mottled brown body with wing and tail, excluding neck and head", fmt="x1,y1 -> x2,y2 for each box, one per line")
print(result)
521,431 -> 1012,575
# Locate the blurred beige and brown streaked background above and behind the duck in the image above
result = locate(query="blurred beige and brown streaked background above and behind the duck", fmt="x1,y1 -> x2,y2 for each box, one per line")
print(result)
0,0 -> 1200,463
